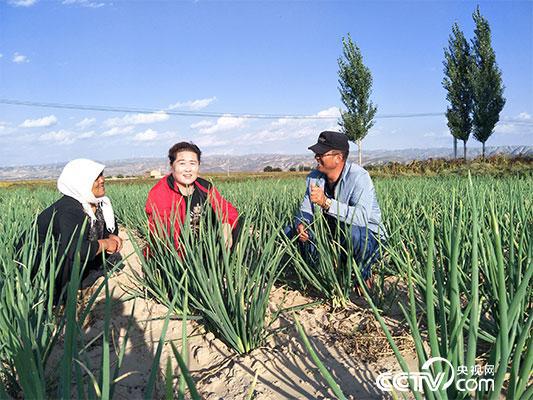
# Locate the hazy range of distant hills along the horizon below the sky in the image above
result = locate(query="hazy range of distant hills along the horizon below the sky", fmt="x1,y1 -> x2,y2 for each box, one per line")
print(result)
0,146 -> 533,181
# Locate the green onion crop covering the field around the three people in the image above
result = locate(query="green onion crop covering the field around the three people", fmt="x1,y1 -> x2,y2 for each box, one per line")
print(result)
0,174 -> 533,399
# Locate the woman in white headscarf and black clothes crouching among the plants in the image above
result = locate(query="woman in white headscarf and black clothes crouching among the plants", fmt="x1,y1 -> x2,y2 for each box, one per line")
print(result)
37,159 -> 122,300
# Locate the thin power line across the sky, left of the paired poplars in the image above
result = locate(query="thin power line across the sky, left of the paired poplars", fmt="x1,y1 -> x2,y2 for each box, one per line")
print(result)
0,99 -> 444,120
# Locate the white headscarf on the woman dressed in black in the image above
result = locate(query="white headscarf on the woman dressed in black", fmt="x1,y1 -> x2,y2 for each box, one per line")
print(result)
57,158 -> 115,232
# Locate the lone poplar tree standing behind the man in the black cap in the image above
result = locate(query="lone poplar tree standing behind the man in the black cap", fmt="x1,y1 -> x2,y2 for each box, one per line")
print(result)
337,34 -> 377,165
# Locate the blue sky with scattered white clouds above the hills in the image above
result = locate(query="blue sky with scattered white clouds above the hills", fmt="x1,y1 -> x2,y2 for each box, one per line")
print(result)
0,0 -> 533,166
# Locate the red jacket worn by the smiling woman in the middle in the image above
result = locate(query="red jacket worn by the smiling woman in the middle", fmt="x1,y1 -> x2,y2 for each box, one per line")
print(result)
145,175 -> 239,248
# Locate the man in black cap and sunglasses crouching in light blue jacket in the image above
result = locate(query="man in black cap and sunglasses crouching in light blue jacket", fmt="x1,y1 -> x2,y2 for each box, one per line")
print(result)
286,131 -> 386,286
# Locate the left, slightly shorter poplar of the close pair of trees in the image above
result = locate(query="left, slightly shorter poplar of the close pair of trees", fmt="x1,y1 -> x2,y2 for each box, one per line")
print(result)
442,23 -> 473,161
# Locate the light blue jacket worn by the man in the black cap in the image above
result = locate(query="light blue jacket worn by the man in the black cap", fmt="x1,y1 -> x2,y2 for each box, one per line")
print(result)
296,163 -> 386,238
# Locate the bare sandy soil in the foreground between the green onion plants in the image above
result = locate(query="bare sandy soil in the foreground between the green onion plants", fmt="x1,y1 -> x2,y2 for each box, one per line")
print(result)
74,232 -> 414,400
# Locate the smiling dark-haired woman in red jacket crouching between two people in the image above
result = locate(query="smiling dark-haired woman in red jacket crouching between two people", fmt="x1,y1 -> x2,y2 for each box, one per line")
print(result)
145,142 -> 239,252
